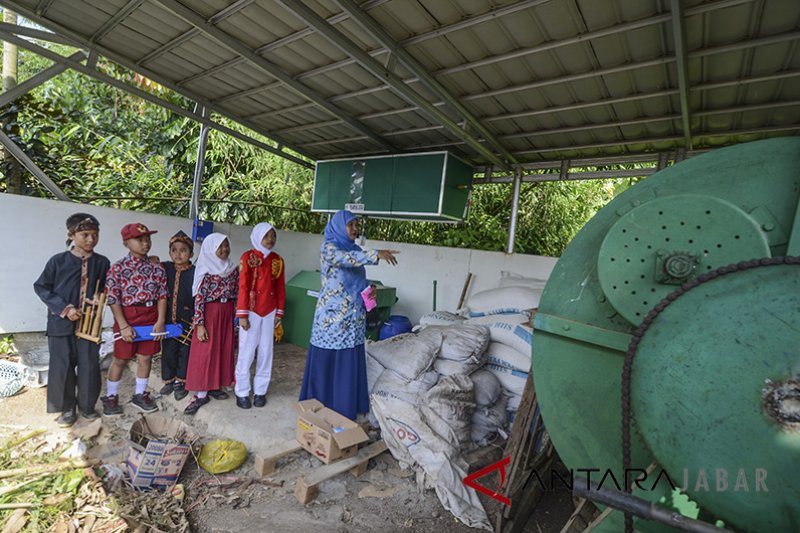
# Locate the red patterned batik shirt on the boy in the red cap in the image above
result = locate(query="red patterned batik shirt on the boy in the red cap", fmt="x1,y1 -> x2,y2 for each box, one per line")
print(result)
106,254 -> 169,307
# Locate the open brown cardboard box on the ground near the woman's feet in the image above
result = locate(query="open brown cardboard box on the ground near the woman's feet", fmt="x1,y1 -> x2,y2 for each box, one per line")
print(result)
294,399 -> 369,464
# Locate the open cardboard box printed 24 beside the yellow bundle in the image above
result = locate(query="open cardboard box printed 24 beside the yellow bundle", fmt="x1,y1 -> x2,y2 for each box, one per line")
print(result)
126,415 -> 197,490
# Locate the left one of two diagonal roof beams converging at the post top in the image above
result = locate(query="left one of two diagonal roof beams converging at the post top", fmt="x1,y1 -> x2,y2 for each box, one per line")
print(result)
277,0 -> 509,168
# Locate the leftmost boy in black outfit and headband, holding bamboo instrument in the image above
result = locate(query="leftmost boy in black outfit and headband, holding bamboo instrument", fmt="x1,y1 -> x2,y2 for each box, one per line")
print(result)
33,213 -> 110,427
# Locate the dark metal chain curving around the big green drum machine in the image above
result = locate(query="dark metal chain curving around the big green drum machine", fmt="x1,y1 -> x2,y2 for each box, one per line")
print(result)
622,256 -> 800,533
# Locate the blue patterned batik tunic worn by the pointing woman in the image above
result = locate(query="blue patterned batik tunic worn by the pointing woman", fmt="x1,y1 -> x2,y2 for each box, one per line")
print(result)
311,243 -> 378,350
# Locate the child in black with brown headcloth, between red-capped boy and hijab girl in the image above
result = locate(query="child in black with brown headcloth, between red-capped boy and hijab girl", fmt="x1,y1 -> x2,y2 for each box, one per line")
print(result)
160,231 -> 194,400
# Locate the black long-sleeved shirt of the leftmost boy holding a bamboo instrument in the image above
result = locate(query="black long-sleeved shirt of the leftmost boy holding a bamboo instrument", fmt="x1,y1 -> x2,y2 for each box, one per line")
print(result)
33,252 -> 110,337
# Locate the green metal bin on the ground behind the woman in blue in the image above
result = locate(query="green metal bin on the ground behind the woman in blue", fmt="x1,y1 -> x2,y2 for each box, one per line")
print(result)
283,270 -> 397,348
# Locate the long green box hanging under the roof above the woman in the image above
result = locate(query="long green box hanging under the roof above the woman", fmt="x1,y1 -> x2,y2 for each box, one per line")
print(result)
311,152 -> 473,222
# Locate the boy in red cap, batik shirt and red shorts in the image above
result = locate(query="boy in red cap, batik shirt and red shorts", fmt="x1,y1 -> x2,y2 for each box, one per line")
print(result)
101,223 -> 168,416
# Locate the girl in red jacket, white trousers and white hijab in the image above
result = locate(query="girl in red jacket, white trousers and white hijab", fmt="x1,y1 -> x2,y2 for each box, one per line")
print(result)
235,222 -> 286,409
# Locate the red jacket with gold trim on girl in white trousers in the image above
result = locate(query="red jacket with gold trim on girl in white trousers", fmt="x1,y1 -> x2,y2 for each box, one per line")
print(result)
236,250 -> 286,317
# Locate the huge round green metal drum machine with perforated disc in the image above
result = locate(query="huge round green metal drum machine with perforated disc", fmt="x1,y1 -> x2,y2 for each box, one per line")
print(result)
532,137 -> 800,532
